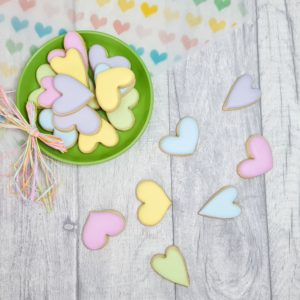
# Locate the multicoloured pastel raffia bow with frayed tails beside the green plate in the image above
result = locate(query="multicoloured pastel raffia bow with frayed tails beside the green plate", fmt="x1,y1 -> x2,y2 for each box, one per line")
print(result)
0,87 -> 67,210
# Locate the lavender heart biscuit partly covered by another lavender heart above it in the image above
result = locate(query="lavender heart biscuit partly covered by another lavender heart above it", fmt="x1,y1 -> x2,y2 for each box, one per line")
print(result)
53,106 -> 101,135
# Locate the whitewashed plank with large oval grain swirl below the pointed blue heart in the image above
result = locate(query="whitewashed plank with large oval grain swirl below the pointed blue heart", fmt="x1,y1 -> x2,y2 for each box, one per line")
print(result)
166,2 -> 270,300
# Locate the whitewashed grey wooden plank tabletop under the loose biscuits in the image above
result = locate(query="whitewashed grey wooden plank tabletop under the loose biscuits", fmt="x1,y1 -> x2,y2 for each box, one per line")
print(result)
0,0 -> 300,300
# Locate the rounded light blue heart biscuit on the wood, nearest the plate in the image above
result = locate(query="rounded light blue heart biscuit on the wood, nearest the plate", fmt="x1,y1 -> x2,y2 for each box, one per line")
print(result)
159,117 -> 199,155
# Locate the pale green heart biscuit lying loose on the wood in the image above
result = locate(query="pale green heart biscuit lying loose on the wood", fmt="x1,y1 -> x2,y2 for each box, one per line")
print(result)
150,245 -> 190,287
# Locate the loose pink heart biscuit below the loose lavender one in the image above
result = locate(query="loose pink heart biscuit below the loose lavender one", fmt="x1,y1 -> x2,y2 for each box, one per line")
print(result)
237,135 -> 273,178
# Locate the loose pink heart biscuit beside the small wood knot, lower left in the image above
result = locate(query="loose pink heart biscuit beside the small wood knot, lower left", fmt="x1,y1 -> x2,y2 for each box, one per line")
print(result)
82,210 -> 125,250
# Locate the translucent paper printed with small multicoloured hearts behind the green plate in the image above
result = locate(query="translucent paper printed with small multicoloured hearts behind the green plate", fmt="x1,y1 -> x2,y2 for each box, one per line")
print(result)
0,0 -> 247,84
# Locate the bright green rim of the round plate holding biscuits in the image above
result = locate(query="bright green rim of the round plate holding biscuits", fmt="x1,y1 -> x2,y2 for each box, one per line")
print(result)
16,30 -> 154,165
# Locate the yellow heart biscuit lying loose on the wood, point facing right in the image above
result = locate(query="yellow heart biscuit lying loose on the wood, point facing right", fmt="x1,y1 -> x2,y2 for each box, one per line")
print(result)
136,180 -> 172,226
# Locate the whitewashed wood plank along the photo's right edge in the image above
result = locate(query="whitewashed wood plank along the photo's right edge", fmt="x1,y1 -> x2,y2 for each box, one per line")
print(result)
257,0 -> 300,300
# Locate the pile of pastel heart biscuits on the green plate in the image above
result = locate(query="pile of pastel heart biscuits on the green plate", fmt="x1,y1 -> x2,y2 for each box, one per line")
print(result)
28,32 -> 139,153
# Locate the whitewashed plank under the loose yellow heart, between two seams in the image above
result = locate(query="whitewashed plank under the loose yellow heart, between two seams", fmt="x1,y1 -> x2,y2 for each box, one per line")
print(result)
78,74 -> 174,300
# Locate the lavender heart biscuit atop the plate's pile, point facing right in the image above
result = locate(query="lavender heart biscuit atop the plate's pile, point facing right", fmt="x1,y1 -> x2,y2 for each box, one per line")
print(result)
53,74 -> 94,116
